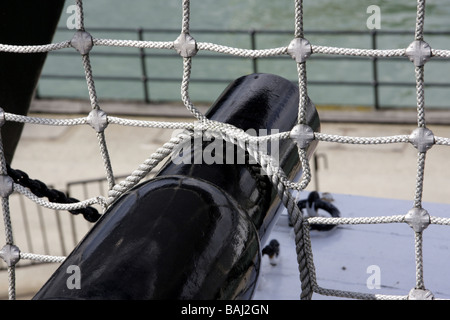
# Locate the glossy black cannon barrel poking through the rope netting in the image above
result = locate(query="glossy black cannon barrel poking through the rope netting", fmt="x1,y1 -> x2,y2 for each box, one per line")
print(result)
34,74 -> 320,300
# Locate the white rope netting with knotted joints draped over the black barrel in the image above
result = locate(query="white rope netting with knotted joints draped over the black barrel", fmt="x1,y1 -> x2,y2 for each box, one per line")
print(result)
0,0 -> 450,299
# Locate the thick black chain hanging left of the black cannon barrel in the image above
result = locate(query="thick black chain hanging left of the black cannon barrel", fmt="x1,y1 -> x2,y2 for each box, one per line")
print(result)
7,165 -> 101,222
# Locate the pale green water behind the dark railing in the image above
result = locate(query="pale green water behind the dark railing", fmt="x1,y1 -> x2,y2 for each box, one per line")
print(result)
39,0 -> 450,108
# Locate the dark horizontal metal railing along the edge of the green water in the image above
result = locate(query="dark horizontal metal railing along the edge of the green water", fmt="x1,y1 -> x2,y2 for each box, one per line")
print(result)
36,28 -> 450,110
